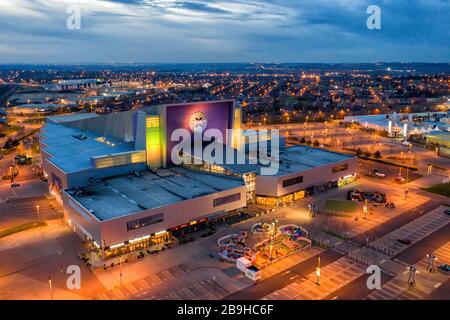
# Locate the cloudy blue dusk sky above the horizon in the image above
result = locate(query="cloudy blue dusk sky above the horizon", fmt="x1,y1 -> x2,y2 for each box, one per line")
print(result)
0,0 -> 450,64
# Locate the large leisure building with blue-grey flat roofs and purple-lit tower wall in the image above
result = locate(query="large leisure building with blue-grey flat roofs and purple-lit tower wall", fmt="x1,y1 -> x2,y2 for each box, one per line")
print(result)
40,100 -> 357,257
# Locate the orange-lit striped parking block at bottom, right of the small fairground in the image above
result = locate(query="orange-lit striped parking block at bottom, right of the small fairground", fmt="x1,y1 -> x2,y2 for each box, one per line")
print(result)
263,257 -> 366,300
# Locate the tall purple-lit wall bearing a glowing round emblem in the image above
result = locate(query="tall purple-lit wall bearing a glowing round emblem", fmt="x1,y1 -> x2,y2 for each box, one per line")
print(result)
166,100 -> 234,164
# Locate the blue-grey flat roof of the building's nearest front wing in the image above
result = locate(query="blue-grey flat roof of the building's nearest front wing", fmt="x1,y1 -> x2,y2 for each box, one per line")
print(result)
66,167 -> 244,221
